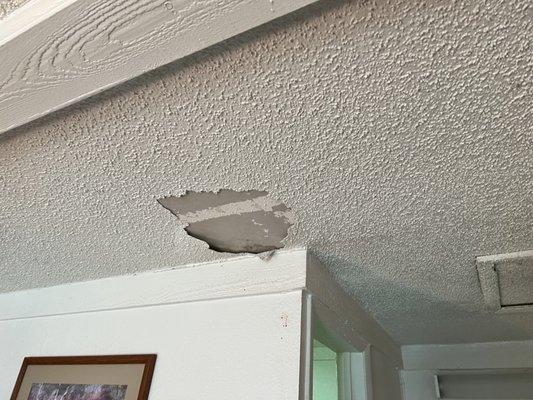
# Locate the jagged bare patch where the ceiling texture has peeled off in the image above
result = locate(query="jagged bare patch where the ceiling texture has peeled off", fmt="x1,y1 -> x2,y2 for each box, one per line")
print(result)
157,189 -> 294,254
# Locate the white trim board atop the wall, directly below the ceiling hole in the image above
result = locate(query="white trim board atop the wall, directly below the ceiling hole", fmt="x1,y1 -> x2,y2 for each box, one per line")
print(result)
0,250 -> 306,321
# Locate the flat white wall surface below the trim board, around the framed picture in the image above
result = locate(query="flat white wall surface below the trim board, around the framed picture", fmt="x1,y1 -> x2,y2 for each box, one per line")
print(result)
0,291 -> 302,400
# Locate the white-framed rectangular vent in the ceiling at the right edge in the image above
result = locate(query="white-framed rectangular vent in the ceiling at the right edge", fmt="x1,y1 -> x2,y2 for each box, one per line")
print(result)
476,250 -> 533,311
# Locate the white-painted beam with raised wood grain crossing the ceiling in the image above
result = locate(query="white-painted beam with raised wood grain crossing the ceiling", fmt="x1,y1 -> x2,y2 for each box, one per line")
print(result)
0,0 -> 316,134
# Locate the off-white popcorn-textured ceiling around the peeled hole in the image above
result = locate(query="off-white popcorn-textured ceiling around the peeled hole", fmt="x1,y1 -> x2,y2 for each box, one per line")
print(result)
0,0 -> 533,343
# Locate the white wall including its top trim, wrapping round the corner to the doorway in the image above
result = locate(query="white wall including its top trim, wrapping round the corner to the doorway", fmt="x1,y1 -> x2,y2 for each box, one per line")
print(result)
0,250 -> 402,400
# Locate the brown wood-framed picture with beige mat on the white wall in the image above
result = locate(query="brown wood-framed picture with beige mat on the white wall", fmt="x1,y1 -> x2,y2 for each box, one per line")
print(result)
11,354 -> 156,400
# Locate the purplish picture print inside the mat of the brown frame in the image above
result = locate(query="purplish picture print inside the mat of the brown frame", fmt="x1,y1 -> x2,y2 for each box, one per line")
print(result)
28,383 -> 128,400
